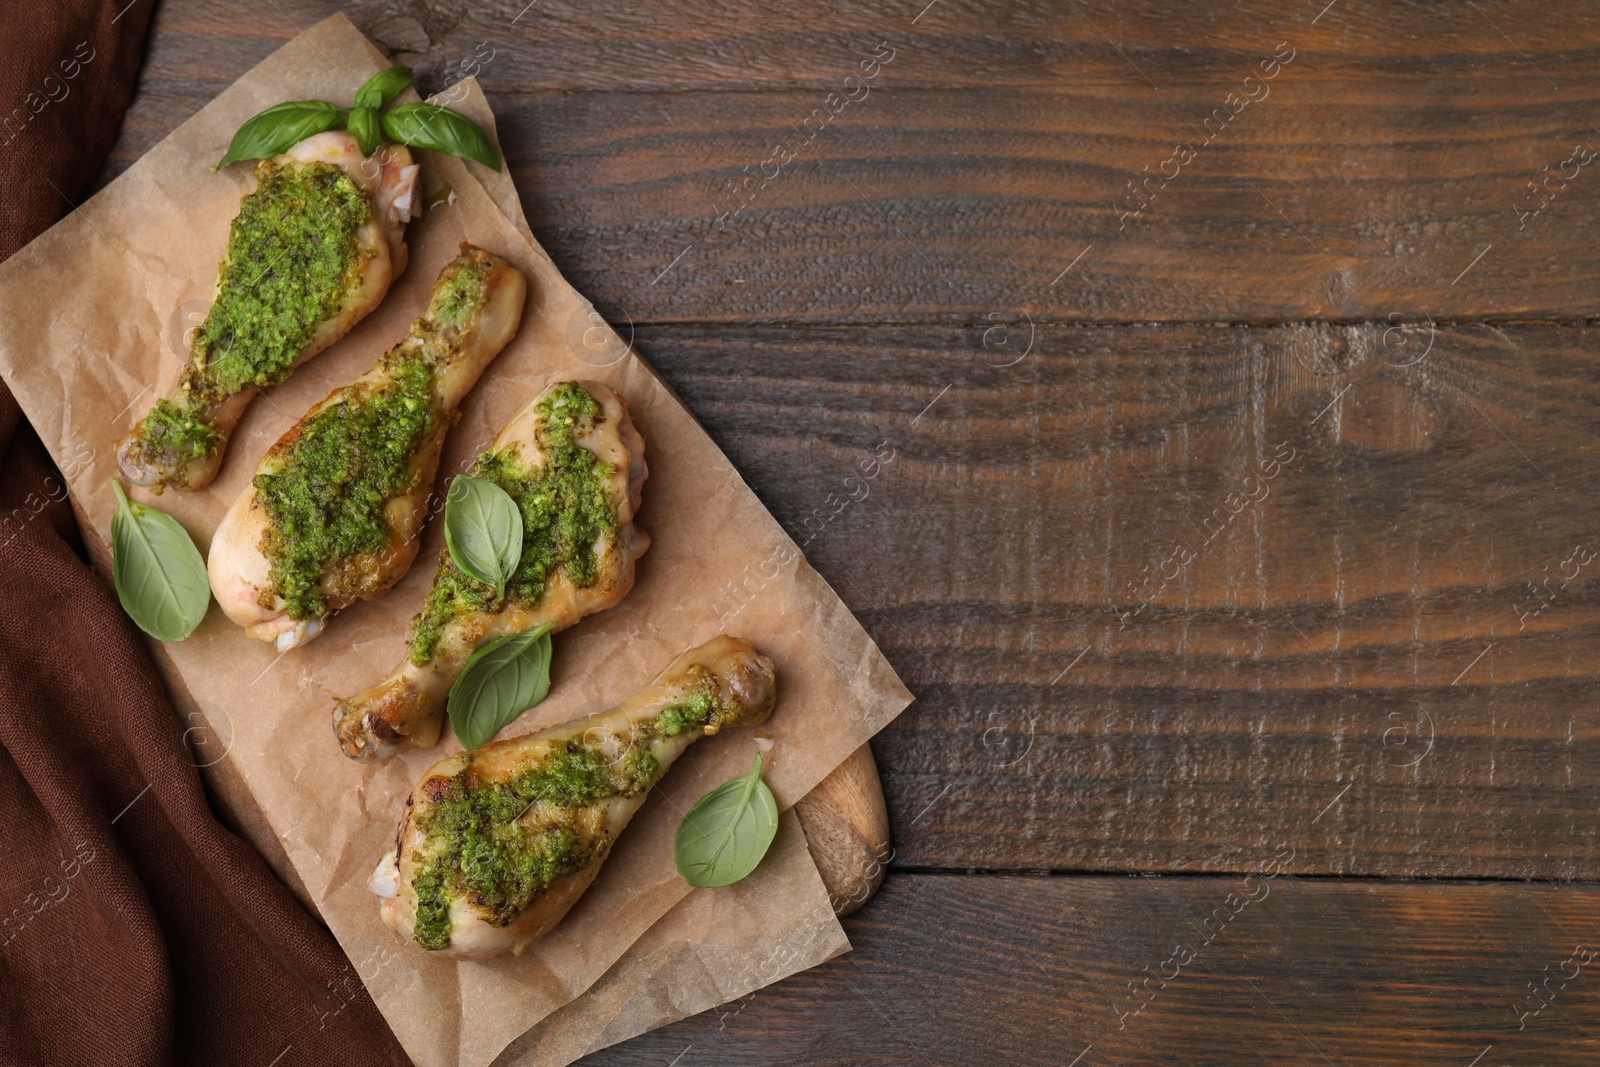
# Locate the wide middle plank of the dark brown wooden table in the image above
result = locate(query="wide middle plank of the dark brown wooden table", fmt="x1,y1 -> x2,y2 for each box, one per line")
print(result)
635,323 -> 1600,878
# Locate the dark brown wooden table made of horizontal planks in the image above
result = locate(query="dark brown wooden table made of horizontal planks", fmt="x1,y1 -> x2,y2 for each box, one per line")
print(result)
110,0 -> 1600,1067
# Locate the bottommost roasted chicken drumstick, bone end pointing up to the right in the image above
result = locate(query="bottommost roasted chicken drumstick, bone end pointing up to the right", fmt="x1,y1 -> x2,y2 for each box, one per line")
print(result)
368,635 -> 776,957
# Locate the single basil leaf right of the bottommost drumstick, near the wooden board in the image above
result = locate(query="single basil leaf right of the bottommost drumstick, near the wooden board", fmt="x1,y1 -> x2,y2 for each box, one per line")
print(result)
672,753 -> 778,886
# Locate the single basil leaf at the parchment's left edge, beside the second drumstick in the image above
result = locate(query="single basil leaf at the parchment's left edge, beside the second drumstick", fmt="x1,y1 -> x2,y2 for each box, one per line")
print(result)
110,480 -> 211,641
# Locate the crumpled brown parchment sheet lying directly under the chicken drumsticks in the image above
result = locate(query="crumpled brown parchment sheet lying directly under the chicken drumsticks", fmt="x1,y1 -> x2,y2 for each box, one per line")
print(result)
0,16 -> 910,1065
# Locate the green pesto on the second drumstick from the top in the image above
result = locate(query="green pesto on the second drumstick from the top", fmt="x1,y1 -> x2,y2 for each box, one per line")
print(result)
256,354 -> 442,619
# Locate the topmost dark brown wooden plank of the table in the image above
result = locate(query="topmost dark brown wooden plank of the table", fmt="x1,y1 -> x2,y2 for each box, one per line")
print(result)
112,0 -> 1600,322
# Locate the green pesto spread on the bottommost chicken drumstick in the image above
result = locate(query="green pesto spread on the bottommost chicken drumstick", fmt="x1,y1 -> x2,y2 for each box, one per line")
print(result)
411,734 -> 658,949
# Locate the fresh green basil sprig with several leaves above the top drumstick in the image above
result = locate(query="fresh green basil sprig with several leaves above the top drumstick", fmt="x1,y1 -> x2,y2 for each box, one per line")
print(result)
218,66 -> 501,171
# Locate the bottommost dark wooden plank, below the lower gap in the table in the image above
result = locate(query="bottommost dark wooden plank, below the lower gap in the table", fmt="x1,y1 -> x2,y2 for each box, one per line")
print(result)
581,876 -> 1600,1067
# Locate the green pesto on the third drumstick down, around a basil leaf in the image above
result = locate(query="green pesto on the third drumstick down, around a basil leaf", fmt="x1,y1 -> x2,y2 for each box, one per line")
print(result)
411,382 -> 618,665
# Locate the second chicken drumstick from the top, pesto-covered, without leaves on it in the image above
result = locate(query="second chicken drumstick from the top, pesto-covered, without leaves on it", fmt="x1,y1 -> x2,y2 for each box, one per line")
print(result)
208,243 -> 528,651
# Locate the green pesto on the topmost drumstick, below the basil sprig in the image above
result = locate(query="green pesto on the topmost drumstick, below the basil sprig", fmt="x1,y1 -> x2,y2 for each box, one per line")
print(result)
184,163 -> 373,402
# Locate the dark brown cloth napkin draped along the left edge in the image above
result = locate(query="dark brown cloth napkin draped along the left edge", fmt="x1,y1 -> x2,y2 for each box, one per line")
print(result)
0,0 -> 406,1067
